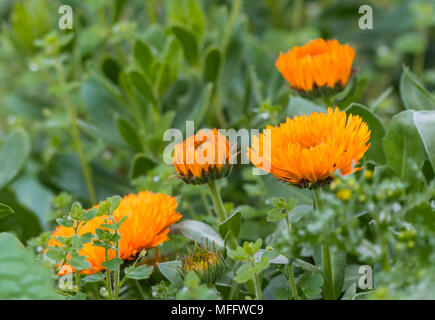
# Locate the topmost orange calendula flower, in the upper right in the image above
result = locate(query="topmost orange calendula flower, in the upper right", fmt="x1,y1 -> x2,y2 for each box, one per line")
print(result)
275,38 -> 355,91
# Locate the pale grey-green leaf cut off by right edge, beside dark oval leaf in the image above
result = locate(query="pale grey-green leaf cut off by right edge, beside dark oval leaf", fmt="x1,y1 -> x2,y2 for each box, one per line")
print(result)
414,111 -> 435,172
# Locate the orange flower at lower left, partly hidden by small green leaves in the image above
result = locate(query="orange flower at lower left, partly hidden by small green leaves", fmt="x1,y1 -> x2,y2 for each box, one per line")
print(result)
48,191 -> 181,275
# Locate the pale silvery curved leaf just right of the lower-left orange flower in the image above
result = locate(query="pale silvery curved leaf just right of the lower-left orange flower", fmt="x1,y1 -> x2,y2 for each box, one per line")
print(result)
171,220 -> 224,248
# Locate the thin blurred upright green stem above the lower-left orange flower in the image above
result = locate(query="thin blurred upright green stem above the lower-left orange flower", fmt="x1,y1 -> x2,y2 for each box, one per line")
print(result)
56,61 -> 97,204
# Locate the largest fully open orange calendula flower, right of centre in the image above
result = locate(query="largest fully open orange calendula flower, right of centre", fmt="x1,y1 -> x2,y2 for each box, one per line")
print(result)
248,108 -> 370,188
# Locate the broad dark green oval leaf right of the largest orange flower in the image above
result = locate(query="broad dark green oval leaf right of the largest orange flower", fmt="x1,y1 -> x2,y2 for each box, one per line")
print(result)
383,110 -> 426,181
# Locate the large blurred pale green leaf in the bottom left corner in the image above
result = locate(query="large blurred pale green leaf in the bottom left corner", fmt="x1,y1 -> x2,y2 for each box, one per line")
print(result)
0,233 -> 62,300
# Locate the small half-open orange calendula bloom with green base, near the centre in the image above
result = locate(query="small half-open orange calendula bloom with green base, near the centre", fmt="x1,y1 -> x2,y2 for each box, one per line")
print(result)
174,129 -> 231,184
